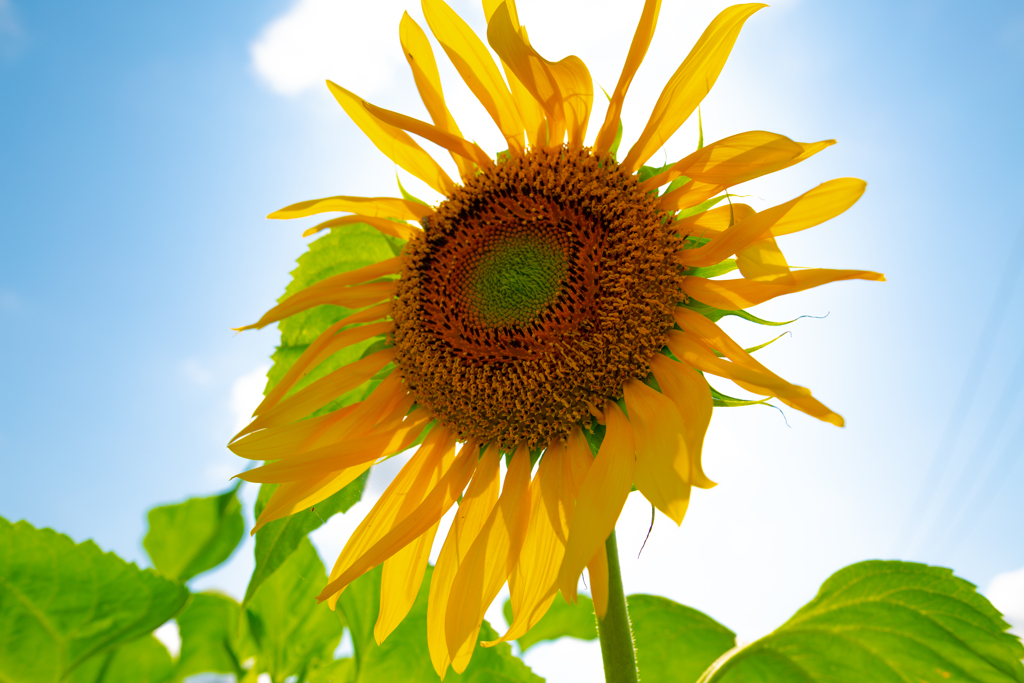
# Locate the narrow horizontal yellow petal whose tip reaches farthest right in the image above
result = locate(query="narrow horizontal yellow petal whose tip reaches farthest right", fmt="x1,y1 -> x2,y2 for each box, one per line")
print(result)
683,268 -> 886,310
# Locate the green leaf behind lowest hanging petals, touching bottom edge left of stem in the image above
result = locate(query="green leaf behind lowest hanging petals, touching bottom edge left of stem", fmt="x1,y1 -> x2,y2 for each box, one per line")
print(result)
338,566 -> 544,683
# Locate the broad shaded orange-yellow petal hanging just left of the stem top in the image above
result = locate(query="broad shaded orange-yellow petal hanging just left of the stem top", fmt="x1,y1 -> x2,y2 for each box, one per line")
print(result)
558,400 -> 636,603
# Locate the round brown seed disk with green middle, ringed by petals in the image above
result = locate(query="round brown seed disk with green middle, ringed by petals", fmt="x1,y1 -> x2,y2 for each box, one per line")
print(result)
392,147 -> 681,449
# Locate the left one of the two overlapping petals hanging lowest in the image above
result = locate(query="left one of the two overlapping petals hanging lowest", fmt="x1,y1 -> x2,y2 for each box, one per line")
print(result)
427,443 -> 502,678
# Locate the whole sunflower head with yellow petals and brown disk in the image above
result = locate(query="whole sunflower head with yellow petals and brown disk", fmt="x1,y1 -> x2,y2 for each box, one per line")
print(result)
230,0 -> 883,676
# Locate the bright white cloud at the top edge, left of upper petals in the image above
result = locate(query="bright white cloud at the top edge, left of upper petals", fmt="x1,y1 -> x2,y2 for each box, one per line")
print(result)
250,0 -> 408,95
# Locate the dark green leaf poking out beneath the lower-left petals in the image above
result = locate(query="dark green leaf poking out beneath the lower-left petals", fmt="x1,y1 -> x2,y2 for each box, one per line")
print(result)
242,472 -> 369,607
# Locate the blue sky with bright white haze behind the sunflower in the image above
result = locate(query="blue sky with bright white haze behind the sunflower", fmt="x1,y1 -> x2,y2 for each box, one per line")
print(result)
0,0 -> 1024,680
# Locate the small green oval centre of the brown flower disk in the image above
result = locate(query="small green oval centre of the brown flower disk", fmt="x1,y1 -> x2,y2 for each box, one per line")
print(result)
468,236 -> 566,328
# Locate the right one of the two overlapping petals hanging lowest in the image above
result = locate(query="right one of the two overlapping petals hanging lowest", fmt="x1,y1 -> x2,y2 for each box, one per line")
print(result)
444,446 -> 530,674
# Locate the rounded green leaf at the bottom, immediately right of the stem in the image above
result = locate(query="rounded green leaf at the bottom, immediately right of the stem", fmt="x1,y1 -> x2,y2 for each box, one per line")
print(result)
627,595 -> 736,683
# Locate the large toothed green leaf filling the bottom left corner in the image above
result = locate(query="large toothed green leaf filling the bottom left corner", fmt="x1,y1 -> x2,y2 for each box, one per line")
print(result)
0,517 -> 188,683
